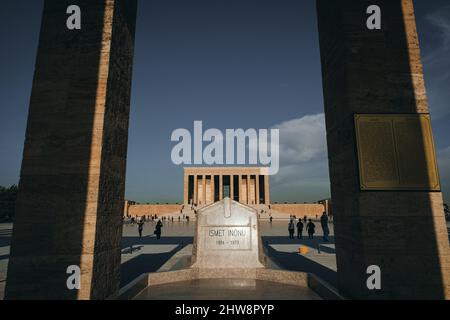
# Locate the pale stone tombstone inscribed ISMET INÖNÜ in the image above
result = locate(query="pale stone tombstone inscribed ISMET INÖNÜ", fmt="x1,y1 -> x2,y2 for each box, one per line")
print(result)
191,198 -> 264,269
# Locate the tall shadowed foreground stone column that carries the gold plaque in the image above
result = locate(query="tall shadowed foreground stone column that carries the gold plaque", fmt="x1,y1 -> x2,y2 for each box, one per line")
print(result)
317,0 -> 450,299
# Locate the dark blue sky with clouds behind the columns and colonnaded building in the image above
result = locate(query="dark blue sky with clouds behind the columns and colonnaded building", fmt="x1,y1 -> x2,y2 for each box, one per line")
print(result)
0,0 -> 450,202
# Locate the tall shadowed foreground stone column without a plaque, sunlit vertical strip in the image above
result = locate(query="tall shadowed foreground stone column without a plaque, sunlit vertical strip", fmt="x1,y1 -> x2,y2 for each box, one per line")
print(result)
6,0 -> 136,299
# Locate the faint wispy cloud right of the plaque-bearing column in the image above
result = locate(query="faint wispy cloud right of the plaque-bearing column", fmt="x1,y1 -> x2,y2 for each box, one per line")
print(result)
423,5 -> 450,119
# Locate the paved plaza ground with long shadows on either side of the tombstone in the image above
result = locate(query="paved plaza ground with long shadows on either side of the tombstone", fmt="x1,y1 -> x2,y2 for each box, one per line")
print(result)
0,220 -> 450,299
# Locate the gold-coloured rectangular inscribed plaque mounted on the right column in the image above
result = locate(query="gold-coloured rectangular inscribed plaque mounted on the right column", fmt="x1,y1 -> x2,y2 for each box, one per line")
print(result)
355,114 -> 440,191
